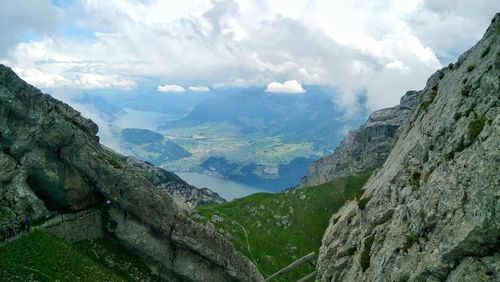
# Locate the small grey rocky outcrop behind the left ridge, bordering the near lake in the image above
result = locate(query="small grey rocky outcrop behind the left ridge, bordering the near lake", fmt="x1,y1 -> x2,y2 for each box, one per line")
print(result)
126,157 -> 226,210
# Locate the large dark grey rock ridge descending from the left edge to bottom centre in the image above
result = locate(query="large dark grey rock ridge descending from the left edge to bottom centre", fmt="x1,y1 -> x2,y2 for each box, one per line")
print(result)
0,65 -> 262,281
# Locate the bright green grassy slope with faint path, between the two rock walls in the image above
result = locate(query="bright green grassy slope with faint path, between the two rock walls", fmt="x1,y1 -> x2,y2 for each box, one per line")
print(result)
193,172 -> 370,281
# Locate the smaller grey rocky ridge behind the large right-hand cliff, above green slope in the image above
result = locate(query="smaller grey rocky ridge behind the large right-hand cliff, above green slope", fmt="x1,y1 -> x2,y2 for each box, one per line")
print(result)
300,91 -> 421,187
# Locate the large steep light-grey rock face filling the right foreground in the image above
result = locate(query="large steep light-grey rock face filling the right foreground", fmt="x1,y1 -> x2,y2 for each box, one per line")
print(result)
317,14 -> 500,281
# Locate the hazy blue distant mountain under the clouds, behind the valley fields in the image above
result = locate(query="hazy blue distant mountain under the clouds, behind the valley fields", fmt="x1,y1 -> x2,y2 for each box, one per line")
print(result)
162,86 -> 362,150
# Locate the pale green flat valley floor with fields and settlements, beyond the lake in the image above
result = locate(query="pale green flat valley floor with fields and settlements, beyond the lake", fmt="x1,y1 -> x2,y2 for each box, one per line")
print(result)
162,122 -> 320,171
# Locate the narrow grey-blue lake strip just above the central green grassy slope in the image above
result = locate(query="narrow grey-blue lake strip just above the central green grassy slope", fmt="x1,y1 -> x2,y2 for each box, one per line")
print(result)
176,172 -> 270,201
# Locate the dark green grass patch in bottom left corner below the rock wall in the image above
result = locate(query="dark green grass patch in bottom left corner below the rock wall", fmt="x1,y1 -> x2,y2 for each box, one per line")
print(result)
0,230 -> 159,282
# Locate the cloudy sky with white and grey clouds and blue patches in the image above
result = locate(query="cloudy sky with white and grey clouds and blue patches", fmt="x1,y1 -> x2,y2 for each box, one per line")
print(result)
0,0 -> 500,110
